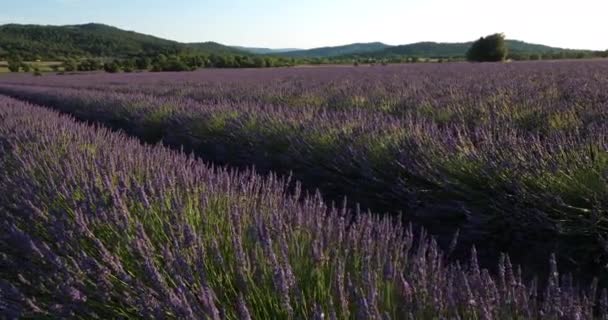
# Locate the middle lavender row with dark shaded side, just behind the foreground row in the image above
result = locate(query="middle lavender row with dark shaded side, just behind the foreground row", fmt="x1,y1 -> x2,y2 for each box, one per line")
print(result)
0,85 -> 608,280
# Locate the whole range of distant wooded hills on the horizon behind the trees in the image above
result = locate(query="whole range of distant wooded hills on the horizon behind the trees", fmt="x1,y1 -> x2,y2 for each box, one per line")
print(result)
0,23 -> 592,63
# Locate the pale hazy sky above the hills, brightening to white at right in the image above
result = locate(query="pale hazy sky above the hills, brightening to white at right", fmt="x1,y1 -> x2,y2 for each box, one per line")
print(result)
0,0 -> 608,50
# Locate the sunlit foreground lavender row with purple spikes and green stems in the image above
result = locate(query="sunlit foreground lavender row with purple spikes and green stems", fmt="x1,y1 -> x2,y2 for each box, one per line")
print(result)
0,96 -> 608,319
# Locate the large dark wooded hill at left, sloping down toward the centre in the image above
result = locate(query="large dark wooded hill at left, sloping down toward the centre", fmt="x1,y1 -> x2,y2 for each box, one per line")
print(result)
0,23 -> 243,60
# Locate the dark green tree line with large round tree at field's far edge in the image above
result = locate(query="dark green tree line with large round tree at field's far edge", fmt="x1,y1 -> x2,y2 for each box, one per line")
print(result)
8,33 -> 608,75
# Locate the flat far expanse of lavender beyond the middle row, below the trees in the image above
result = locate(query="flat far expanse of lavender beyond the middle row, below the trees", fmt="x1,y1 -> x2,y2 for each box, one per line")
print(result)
3,60 -> 608,135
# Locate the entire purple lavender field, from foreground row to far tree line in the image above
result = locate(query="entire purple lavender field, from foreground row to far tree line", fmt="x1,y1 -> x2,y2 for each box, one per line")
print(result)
0,60 -> 608,319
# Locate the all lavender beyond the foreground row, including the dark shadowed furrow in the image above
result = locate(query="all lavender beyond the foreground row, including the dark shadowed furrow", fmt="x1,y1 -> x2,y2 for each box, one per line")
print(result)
0,62 -> 608,280
